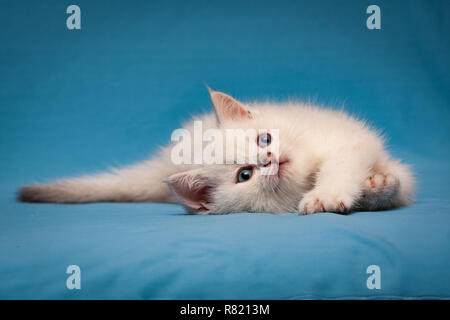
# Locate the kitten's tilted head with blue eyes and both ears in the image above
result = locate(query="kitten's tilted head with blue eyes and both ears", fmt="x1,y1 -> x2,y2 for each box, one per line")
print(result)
168,90 -> 312,214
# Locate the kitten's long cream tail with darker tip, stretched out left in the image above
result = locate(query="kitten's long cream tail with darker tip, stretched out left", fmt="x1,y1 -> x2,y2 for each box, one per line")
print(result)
17,160 -> 177,203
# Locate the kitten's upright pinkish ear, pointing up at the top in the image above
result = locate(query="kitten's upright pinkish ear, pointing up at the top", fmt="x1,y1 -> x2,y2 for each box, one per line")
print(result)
207,87 -> 253,122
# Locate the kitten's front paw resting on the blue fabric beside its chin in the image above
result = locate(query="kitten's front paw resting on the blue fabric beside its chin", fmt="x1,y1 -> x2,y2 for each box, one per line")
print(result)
298,190 -> 353,215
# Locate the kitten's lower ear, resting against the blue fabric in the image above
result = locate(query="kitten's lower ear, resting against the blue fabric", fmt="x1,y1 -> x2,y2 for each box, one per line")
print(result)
166,169 -> 214,214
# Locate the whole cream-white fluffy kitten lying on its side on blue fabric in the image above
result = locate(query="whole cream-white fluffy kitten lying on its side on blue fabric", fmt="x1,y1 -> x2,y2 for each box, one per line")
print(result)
18,90 -> 414,214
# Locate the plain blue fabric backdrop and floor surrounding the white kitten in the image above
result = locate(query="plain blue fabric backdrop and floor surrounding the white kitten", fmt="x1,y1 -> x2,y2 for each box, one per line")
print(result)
0,0 -> 450,299
